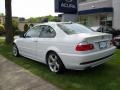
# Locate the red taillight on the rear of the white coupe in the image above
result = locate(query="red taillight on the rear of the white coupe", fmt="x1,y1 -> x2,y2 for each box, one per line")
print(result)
76,44 -> 94,51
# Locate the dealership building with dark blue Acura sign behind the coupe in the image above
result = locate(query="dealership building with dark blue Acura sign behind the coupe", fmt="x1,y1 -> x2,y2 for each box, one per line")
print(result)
55,0 -> 120,29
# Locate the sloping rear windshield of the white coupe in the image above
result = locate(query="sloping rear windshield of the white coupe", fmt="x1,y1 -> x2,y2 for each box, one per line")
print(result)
57,23 -> 93,35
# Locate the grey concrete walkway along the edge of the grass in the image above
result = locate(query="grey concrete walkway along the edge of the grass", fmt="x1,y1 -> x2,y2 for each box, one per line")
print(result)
0,55 -> 58,90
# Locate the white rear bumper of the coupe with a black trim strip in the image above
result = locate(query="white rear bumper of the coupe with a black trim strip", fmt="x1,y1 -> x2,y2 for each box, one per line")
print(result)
59,47 -> 116,70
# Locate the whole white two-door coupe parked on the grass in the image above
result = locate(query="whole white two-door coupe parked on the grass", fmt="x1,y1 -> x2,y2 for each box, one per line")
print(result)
13,22 -> 116,73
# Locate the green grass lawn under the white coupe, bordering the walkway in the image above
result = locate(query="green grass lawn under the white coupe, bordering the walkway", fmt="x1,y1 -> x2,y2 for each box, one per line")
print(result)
0,40 -> 120,90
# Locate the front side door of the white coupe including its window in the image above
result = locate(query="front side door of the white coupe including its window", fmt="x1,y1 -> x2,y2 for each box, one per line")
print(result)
20,27 -> 40,59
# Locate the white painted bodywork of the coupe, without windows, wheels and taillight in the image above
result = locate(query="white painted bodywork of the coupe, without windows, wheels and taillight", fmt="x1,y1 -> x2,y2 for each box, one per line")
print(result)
14,22 -> 116,70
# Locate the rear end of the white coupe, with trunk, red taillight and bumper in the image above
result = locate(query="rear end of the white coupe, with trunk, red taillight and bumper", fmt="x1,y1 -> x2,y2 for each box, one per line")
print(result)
59,22 -> 116,70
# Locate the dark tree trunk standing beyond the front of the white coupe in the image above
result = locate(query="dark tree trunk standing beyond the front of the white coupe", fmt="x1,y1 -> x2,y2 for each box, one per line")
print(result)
5,0 -> 13,44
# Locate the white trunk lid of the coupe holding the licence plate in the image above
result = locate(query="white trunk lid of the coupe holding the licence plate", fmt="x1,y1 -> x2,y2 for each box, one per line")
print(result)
68,32 -> 112,53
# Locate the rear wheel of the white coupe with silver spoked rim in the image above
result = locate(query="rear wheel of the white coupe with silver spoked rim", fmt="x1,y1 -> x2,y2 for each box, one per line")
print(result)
46,52 -> 65,73
